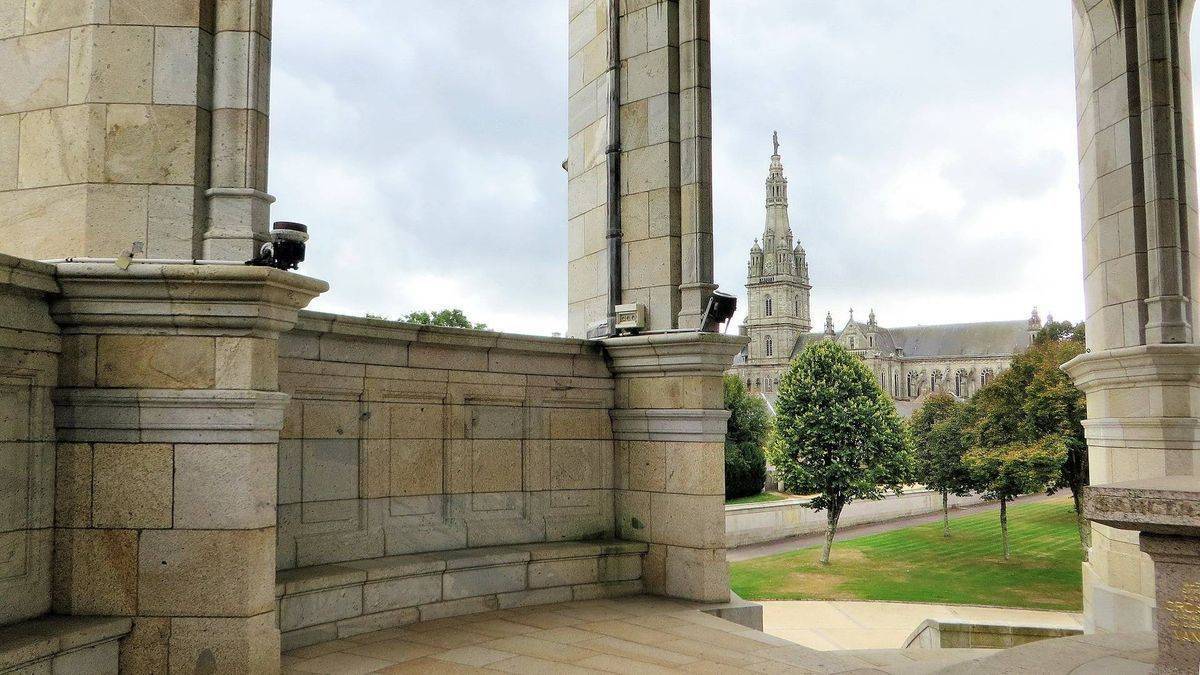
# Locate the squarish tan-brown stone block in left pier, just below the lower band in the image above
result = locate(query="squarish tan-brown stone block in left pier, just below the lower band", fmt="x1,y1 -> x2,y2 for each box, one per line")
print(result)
91,443 -> 174,527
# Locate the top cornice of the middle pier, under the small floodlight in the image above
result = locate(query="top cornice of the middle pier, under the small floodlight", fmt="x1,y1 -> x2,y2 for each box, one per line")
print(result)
602,330 -> 750,377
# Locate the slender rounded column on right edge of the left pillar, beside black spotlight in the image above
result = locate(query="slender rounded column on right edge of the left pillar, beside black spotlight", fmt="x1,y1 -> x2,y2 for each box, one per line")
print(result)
204,0 -> 275,261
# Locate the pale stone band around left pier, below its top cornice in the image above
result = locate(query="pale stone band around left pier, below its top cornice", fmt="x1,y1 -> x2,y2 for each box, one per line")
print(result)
54,389 -> 289,443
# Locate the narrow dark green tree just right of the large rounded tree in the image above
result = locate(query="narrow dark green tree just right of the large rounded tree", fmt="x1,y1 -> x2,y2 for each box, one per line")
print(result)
908,394 -> 972,537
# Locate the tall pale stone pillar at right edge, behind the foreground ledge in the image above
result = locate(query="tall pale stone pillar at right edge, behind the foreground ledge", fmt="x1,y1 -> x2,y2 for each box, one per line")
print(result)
1064,0 -> 1200,632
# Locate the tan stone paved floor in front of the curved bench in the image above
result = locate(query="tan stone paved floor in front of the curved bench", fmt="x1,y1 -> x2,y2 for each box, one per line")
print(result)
283,596 -> 979,674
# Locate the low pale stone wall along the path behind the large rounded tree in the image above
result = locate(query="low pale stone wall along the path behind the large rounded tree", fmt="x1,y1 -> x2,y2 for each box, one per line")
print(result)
725,489 -> 983,549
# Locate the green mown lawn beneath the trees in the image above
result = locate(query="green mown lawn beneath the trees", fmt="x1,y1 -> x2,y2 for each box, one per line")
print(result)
731,497 -> 1082,611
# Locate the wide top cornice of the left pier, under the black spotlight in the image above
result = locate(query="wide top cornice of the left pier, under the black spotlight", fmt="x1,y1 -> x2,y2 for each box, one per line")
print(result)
50,263 -> 329,336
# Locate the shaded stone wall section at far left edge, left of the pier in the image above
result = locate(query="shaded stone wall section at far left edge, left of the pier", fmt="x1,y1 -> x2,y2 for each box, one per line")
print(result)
0,255 -> 60,626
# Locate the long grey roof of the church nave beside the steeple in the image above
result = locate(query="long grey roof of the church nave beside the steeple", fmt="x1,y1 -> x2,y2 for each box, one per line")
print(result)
792,319 -> 1030,358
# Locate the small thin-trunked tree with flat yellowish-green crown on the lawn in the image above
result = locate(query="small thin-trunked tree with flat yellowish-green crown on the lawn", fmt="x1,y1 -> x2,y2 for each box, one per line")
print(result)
962,436 -> 1067,560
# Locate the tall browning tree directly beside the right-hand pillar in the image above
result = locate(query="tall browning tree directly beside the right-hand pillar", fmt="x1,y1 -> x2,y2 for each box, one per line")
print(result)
971,322 -> 1088,555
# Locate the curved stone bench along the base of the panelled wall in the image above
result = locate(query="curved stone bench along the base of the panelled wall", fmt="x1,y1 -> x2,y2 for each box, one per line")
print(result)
275,540 -> 647,651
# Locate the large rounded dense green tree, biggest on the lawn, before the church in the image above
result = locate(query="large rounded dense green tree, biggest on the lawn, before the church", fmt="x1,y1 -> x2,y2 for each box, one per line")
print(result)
768,341 -> 912,565
